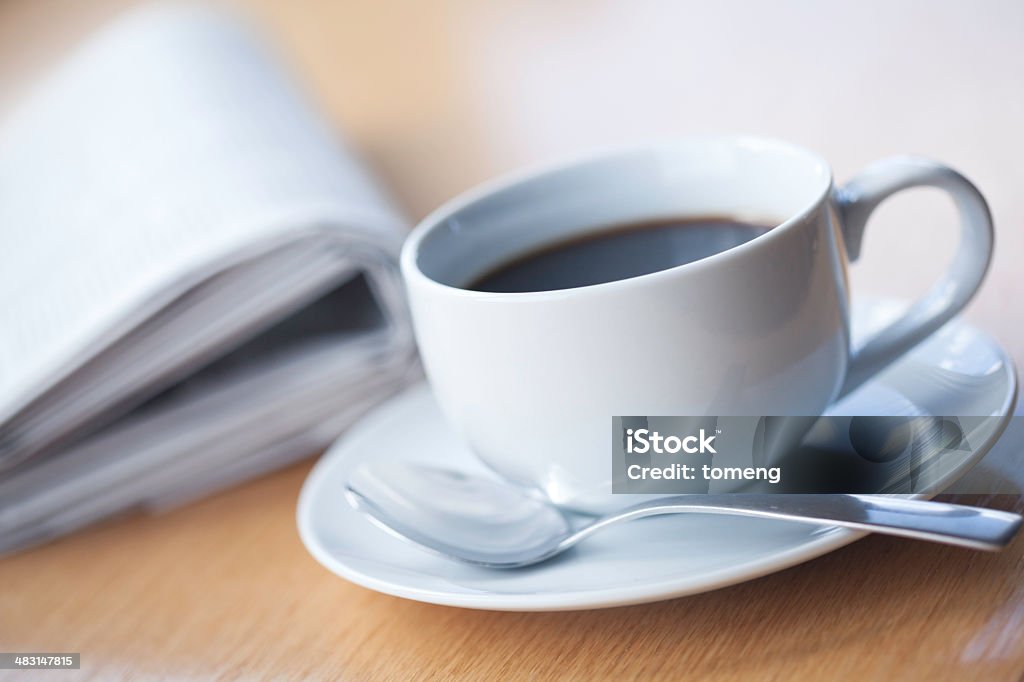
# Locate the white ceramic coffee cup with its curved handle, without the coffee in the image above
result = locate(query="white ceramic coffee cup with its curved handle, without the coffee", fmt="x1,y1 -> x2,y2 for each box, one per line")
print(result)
401,136 -> 992,512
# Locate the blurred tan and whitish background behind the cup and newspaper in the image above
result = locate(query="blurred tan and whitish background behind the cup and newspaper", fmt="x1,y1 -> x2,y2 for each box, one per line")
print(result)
0,0 -> 1024,372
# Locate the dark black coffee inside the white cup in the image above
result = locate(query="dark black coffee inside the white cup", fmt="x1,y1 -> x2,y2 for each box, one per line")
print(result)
466,218 -> 771,293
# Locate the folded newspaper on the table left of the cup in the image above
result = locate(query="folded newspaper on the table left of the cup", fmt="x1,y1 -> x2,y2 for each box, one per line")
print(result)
0,7 -> 419,552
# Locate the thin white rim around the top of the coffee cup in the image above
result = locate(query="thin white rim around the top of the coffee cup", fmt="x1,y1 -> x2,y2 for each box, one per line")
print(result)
399,134 -> 834,301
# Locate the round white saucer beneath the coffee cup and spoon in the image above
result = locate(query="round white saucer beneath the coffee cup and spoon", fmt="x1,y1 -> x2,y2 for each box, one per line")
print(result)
298,302 -> 1017,611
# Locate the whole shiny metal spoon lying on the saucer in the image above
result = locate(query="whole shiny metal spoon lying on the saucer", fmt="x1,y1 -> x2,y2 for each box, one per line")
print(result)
346,462 -> 1024,568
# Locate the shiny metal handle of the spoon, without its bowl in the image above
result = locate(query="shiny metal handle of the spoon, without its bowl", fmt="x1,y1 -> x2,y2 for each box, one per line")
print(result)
573,494 -> 1024,550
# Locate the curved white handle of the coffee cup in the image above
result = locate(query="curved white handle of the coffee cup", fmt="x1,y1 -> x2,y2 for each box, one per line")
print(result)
836,157 -> 993,397
